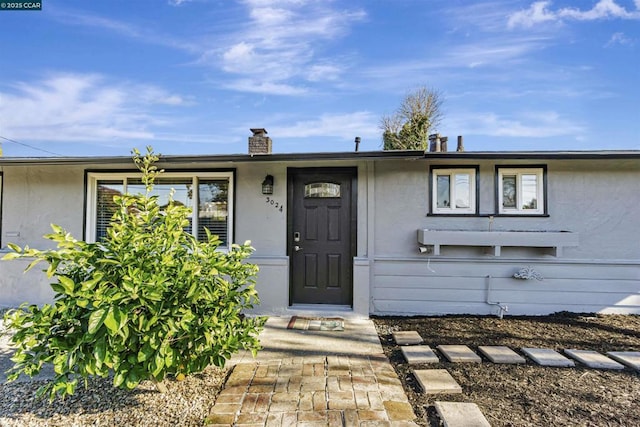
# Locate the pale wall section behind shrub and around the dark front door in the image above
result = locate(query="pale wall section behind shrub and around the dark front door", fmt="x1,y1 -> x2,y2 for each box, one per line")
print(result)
0,161 -> 369,316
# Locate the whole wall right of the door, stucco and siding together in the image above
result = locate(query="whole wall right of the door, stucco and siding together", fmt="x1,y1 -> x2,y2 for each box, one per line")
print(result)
370,160 -> 640,315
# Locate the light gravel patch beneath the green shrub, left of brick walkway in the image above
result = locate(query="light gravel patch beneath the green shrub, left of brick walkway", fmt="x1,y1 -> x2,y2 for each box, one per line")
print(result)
0,367 -> 226,427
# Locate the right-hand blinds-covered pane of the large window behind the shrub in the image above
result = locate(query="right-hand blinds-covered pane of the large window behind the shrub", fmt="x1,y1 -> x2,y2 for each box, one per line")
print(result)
198,179 -> 229,246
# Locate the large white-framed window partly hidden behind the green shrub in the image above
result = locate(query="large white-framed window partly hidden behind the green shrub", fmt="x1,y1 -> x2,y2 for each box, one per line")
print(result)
86,172 -> 233,247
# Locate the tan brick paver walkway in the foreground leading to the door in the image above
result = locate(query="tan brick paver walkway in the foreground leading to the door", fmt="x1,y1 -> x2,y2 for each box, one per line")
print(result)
205,355 -> 417,427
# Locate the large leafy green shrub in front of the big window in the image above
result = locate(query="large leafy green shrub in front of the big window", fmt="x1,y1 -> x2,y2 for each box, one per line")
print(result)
3,147 -> 265,400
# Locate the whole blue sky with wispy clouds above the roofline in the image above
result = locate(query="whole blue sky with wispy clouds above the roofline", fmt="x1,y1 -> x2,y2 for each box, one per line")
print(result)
0,0 -> 640,157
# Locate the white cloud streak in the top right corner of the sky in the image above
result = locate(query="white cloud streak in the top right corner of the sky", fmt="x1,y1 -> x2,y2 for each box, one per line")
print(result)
507,0 -> 640,28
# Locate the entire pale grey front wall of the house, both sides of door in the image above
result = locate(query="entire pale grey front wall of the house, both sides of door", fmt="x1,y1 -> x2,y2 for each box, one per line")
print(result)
0,155 -> 640,315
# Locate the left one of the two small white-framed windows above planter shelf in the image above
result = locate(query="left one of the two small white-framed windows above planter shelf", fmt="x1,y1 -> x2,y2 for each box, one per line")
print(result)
431,168 -> 478,215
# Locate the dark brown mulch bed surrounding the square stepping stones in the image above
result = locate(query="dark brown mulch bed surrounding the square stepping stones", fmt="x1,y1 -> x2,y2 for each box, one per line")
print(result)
373,313 -> 640,427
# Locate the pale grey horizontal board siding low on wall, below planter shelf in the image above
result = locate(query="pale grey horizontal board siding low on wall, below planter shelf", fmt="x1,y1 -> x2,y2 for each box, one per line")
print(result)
371,258 -> 640,316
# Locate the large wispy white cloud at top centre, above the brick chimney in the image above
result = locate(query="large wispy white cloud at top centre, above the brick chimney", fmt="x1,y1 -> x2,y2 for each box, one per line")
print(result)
212,0 -> 366,95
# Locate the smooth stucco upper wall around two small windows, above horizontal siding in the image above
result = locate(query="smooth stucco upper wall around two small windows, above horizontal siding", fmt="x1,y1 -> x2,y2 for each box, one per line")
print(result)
375,160 -> 640,260
